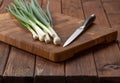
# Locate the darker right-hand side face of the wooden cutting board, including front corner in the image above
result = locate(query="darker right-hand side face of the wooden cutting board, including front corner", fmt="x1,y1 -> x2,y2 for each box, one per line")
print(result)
49,30 -> 118,62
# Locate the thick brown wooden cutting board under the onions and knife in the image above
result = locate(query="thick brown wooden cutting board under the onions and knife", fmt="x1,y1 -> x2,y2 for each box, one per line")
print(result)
0,13 -> 117,62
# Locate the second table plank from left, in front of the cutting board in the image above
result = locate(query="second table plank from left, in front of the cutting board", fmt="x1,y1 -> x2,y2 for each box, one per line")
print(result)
3,47 -> 35,83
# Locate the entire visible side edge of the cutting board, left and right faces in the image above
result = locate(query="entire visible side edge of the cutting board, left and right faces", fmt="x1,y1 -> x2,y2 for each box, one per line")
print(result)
0,30 -> 118,62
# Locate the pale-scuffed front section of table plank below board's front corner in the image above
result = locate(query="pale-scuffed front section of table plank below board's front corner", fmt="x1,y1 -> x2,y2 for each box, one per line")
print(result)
35,56 -> 65,83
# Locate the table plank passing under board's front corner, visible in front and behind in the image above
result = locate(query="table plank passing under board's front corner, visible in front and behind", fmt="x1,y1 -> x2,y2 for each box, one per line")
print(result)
35,0 -> 65,83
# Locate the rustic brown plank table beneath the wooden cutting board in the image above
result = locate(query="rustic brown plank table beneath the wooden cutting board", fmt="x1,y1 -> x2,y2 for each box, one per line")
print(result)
0,0 -> 120,83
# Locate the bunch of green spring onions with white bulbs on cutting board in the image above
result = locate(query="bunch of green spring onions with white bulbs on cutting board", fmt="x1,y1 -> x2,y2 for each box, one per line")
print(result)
8,0 -> 61,45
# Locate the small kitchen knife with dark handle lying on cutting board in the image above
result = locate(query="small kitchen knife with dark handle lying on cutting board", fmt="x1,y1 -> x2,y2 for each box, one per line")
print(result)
63,14 -> 96,47
